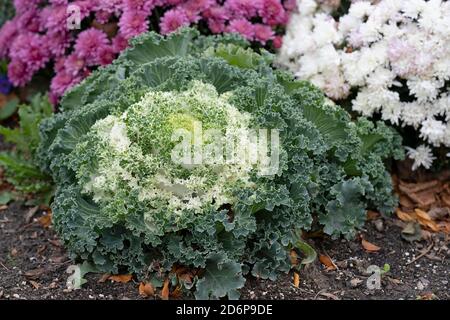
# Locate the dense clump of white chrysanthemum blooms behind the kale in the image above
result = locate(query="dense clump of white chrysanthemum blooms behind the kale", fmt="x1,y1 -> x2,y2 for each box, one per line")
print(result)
277,0 -> 450,162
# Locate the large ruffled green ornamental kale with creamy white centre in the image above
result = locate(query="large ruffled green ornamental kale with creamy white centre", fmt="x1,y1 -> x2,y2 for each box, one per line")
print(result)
40,29 -> 401,298
